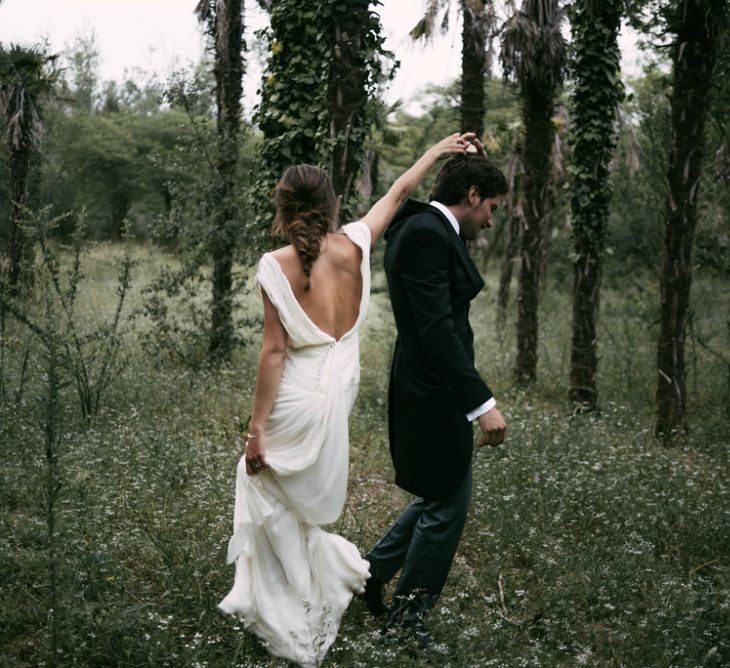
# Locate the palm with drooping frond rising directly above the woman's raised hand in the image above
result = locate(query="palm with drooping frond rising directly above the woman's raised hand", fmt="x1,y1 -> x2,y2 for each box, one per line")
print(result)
411,0 -> 494,137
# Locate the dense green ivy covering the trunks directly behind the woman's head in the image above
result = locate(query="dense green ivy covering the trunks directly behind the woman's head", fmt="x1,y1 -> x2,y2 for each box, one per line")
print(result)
252,0 -> 391,232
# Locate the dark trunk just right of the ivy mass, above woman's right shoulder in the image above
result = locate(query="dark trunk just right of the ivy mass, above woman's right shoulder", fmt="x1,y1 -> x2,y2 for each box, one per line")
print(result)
327,0 -> 370,211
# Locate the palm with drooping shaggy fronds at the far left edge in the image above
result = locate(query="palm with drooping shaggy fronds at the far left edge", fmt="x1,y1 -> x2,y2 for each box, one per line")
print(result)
0,44 -> 57,291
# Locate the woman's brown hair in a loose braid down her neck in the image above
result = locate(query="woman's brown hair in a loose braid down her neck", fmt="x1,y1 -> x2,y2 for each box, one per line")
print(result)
271,165 -> 338,290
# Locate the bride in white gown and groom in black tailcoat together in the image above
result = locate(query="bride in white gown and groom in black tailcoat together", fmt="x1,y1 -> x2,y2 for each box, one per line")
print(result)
219,133 -> 507,668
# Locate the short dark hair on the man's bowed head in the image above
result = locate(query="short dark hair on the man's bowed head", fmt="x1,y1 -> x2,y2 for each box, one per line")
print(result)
431,155 -> 508,206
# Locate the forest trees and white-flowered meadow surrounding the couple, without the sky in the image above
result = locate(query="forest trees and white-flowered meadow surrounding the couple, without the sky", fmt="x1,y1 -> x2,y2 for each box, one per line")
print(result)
0,0 -> 730,666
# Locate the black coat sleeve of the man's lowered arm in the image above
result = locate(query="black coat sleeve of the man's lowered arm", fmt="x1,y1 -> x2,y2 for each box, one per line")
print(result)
397,215 -> 492,416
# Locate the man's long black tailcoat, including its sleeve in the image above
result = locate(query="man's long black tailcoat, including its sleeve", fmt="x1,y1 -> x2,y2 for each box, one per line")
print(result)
378,200 -> 492,500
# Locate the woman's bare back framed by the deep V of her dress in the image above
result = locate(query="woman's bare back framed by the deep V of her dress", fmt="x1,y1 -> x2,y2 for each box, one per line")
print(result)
272,234 -> 362,339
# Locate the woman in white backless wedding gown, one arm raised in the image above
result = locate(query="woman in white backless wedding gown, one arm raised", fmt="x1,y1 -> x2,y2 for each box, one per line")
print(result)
219,133 -> 474,668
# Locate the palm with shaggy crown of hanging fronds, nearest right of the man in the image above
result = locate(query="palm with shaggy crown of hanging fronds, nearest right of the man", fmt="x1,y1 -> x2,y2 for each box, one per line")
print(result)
500,0 -> 566,384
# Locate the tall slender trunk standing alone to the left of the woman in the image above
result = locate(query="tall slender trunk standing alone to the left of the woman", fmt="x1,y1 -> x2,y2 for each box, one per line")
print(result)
210,0 -> 244,359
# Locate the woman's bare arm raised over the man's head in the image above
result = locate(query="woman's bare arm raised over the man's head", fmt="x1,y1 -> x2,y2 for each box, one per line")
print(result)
361,132 -> 475,245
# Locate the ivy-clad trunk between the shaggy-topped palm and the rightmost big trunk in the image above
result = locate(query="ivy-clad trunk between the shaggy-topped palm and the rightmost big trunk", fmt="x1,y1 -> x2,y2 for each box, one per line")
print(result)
570,0 -> 624,410
